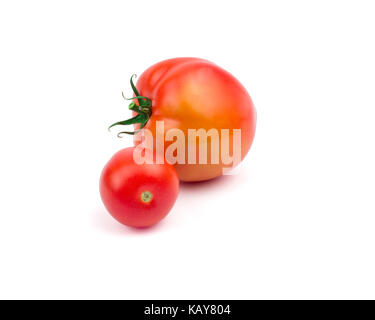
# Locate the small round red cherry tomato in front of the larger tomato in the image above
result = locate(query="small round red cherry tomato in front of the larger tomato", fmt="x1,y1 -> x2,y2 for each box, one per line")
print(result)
100,147 -> 179,227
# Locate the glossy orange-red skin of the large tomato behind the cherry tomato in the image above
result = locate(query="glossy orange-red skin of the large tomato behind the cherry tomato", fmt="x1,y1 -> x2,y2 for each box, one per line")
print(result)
134,58 -> 256,181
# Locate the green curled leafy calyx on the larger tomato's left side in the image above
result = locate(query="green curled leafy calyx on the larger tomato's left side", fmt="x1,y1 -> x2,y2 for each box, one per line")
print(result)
108,74 -> 152,138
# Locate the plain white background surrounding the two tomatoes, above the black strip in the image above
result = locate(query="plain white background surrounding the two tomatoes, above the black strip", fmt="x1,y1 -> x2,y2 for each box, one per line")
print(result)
0,0 -> 375,299
